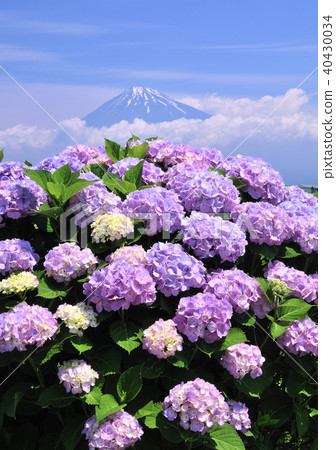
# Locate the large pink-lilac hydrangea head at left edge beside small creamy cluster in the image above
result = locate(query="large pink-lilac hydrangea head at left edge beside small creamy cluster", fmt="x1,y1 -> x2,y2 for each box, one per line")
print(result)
0,302 -> 58,353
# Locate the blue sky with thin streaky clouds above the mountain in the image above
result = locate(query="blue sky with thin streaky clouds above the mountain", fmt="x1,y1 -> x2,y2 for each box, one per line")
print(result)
0,0 -> 317,183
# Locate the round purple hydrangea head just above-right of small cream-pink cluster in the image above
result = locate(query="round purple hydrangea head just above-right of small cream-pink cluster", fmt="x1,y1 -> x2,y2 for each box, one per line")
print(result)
173,292 -> 233,344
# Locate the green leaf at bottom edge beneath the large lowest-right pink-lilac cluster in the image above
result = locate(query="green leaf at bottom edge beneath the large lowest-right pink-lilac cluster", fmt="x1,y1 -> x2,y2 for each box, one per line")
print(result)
204,423 -> 245,450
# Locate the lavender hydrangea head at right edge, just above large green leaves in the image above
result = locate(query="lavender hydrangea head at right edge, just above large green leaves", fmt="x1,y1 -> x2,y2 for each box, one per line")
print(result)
265,261 -> 317,303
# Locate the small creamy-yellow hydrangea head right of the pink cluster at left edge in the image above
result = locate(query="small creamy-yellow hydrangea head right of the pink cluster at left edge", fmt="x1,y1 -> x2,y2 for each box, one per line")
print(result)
54,303 -> 98,336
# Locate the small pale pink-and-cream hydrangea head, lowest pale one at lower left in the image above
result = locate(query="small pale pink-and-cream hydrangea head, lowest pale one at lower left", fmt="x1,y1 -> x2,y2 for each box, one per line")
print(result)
57,359 -> 99,394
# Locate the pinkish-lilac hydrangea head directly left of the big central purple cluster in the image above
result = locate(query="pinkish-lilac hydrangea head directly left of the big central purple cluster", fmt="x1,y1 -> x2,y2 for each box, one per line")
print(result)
44,242 -> 98,283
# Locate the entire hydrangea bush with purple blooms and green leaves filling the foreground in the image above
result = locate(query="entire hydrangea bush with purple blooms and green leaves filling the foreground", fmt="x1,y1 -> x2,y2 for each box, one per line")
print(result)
0,135 -> 318,450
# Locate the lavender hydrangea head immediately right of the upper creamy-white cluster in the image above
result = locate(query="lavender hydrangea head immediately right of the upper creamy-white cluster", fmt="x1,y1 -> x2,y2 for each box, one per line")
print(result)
123,186 -> 184,236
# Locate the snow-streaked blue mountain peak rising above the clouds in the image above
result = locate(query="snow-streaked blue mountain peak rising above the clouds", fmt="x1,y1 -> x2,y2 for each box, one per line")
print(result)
83,87 -> 211,128
